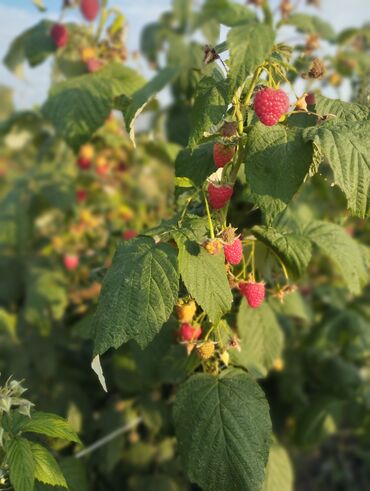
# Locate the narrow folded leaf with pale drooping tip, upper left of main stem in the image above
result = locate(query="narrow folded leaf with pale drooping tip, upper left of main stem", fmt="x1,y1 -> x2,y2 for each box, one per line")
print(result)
116,67 -> 179,144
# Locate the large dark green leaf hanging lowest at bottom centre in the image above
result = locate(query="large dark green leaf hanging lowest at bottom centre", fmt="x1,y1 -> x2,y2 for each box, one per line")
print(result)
174,369 -> 271,491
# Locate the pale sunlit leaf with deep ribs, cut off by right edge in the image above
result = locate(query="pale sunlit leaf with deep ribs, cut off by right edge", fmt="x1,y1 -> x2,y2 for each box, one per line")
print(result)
303,121 -> 370,217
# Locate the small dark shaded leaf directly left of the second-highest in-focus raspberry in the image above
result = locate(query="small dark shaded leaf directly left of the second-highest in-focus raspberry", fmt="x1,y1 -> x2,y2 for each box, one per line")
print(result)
175,143 -> 216,186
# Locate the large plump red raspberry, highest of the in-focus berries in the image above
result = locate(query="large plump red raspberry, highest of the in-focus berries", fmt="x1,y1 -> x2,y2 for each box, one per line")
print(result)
254,88 -> 289,126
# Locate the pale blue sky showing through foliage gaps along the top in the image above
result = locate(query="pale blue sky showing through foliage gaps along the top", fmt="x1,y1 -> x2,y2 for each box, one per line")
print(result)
0,0 -> 370,108
